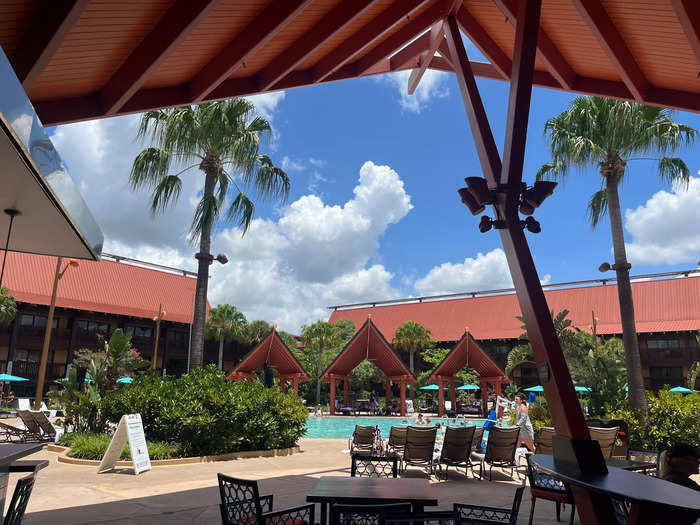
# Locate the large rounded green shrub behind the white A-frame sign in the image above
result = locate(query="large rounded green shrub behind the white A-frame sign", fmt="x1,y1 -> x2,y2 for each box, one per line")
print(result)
102,365 -> 307,456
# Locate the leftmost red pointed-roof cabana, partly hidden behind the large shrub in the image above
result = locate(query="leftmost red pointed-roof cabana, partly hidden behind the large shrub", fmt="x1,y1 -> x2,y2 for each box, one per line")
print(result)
227,326 -> 309,392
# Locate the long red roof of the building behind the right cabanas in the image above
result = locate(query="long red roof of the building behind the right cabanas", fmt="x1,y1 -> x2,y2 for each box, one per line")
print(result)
330,277 -> 700,341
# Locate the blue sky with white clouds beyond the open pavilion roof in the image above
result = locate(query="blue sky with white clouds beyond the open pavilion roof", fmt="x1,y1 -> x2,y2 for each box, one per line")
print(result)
53,62 -> 700,331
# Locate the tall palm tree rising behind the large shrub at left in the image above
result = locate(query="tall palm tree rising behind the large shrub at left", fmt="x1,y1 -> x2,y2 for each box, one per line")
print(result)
129,98 -> 290,367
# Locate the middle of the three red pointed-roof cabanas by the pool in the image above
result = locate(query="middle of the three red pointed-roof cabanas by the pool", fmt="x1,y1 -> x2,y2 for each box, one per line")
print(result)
320,318 -> 416,416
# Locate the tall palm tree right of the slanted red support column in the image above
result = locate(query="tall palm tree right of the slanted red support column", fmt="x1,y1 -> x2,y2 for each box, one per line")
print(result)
537,97 -> 697,420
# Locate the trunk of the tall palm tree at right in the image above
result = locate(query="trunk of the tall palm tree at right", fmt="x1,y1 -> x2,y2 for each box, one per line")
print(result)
605,173 -> 647,422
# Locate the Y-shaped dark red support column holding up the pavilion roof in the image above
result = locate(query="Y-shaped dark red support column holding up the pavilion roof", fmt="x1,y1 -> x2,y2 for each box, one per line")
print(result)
444,0 -> 615,525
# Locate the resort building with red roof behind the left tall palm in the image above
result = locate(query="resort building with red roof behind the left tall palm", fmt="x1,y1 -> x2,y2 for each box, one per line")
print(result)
0,251 -> 247,396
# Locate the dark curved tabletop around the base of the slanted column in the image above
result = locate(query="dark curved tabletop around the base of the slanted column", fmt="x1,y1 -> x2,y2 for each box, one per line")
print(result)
532,454 -> 700,523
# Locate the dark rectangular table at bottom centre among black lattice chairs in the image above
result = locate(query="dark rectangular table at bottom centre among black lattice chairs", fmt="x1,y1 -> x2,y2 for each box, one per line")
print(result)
306,476 -> 438,525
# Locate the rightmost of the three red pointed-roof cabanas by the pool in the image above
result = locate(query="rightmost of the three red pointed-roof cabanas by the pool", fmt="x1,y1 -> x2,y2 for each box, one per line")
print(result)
428,330 -> 510,416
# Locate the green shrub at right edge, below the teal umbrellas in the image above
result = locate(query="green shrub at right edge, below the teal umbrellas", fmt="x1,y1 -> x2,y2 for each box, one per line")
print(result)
608,390 -> 700,450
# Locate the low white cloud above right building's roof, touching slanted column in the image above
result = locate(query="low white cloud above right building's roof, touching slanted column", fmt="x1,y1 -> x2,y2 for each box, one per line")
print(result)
414,248 -> 512,296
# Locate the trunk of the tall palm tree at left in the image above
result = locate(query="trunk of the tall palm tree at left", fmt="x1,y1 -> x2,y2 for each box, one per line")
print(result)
190,165 -> 217,368
